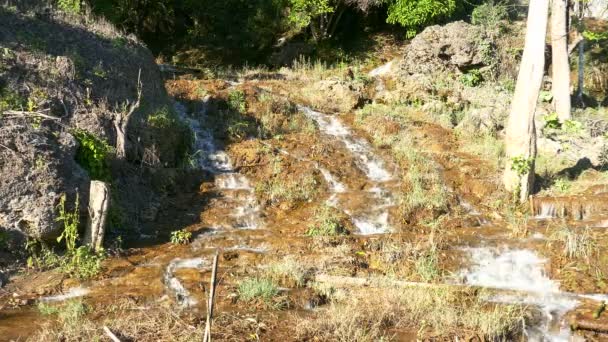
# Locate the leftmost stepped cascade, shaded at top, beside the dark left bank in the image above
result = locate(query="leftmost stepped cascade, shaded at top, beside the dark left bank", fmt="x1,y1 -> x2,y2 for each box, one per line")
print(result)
175,99 -> 261,229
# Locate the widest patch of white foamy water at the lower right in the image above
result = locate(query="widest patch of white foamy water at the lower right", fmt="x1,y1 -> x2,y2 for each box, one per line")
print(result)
461,248 -> 578,342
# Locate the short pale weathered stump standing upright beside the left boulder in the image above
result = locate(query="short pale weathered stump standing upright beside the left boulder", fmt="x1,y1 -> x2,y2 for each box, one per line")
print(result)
84,181 -> 110,252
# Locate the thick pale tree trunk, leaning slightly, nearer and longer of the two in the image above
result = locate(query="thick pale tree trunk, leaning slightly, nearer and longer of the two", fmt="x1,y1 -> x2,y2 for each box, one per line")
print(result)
503,0 -> 549,202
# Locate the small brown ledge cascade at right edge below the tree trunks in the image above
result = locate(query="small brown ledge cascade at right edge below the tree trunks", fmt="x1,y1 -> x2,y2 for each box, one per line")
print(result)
530,195 -> 608,220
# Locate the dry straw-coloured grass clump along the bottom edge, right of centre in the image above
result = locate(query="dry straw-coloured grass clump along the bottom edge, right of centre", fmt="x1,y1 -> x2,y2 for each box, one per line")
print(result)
296,288 -> 527,341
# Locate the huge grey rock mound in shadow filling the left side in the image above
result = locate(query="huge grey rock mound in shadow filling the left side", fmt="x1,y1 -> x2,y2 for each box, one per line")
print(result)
0,6 -> 183,239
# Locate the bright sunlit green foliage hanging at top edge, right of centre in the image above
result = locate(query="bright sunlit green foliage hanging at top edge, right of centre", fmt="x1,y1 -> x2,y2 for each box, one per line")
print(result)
386,0 -> 457,38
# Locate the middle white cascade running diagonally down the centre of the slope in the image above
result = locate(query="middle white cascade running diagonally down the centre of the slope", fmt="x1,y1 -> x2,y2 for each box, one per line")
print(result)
298,106 -> 393,235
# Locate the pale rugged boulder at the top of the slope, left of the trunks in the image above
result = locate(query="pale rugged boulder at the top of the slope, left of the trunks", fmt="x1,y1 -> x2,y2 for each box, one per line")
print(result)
400,21 -> 483,75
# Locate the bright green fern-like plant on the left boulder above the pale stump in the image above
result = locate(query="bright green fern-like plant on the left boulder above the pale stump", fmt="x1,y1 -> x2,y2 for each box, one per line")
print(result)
72,129 -> 113,180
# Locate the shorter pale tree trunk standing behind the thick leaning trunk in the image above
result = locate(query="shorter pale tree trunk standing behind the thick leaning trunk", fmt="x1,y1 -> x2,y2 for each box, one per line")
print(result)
551,0 -> 571,122
